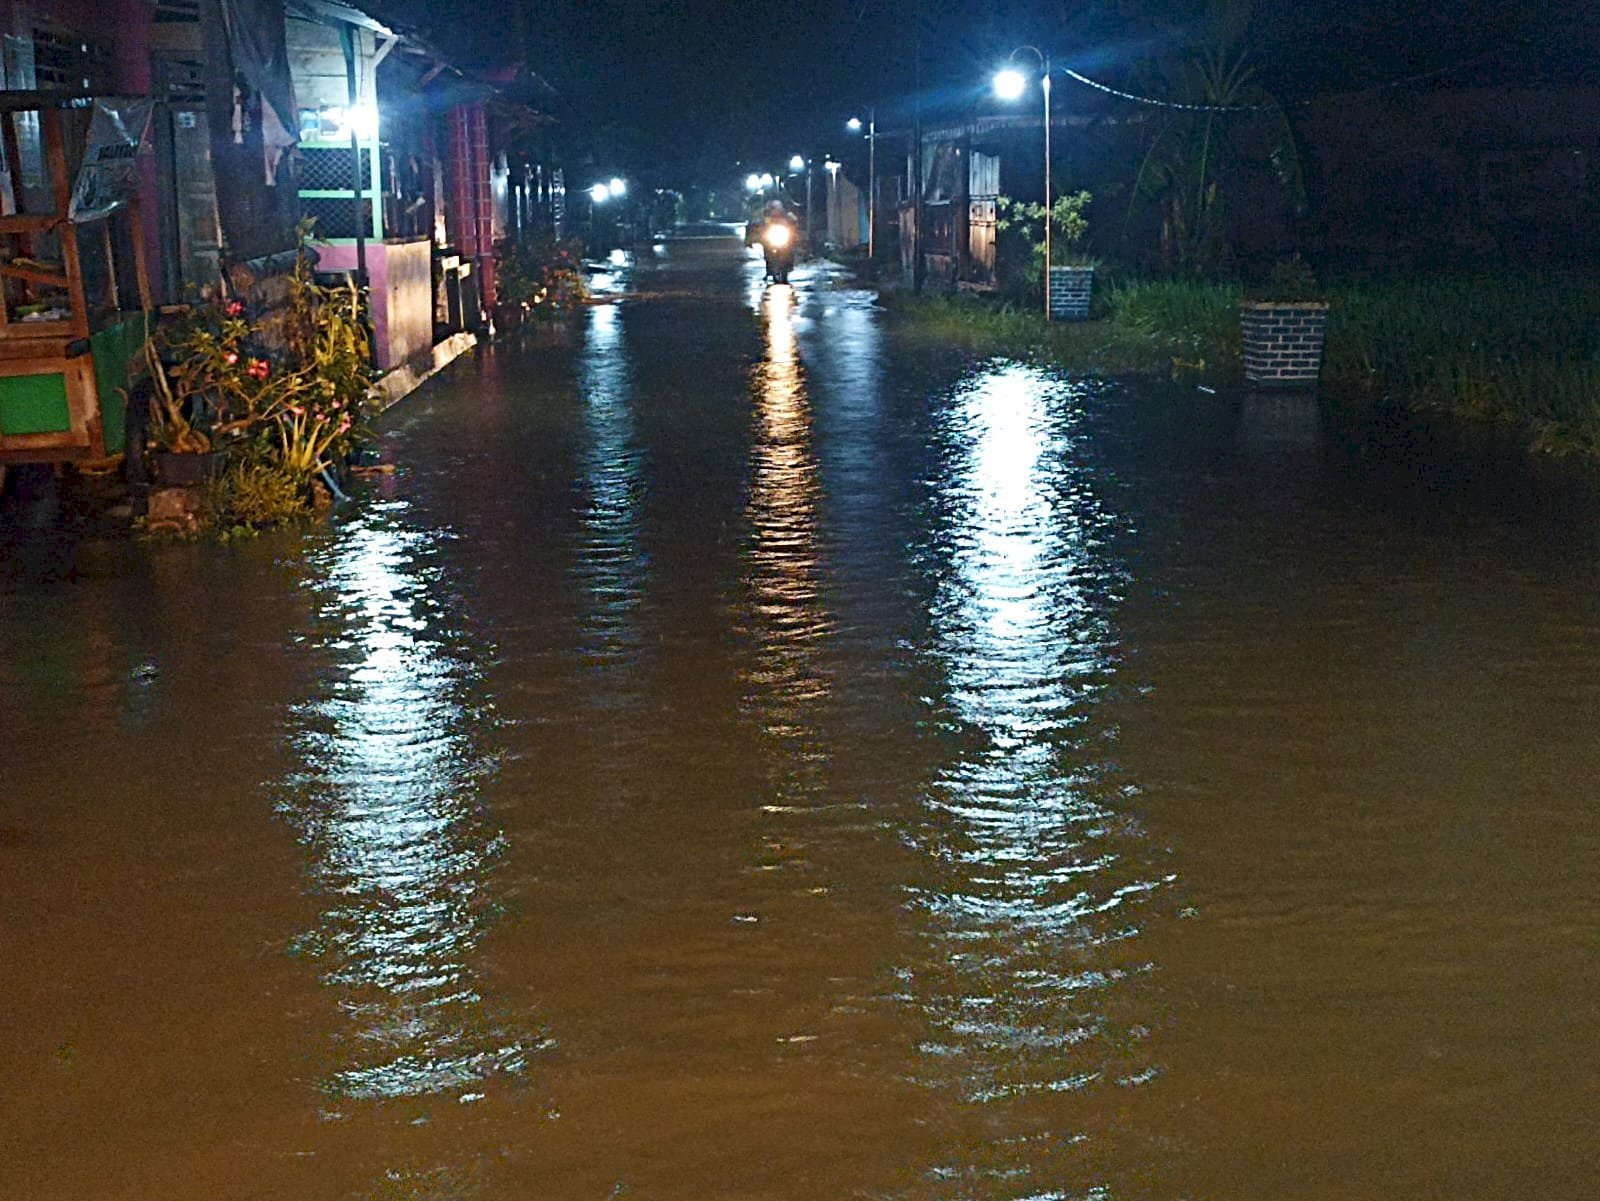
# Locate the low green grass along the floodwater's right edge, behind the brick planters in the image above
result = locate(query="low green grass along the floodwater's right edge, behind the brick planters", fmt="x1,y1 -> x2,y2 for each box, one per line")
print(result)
885,270 -> 1600,457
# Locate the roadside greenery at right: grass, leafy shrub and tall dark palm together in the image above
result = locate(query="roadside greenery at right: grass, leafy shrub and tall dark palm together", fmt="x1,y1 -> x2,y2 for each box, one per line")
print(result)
883,0 -> 1600,457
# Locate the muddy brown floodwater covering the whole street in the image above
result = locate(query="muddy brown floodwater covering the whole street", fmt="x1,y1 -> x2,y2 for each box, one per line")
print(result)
0,241 -> 1600,1201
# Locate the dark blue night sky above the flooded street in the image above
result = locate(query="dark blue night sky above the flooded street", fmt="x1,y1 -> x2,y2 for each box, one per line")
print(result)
409,0 -> 1600,178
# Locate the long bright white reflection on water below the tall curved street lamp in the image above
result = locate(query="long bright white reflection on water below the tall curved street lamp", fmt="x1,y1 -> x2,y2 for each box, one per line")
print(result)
902,363 -> 1162,1196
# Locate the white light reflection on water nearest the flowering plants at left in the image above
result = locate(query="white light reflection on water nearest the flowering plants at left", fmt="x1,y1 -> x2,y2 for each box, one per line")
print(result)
282,505 -> 538,1099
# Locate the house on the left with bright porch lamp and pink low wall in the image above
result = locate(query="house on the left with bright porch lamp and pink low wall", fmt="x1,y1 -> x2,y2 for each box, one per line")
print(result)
0,0 -> 563,369
